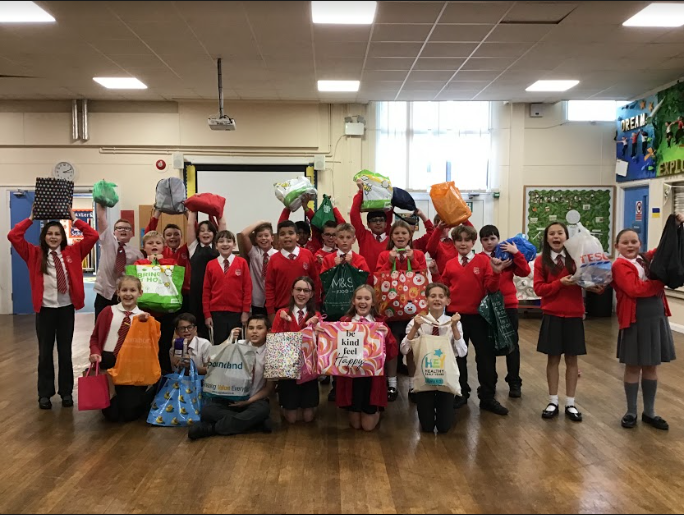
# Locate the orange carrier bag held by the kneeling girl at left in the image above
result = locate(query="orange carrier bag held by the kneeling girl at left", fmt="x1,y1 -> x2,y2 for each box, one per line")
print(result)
107,317 -> 161,386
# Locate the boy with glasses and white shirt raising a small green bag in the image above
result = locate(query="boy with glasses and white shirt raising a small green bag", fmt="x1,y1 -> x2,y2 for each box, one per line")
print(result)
93,204 -> 143,320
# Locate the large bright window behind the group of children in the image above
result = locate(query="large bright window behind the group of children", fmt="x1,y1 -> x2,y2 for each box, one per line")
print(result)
375,102 -> 491,191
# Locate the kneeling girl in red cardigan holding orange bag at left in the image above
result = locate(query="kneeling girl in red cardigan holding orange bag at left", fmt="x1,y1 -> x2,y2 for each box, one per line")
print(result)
90,275 -> 158,422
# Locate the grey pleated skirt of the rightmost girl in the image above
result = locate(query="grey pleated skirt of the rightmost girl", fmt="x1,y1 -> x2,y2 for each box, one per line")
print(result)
617,296 -> 675,367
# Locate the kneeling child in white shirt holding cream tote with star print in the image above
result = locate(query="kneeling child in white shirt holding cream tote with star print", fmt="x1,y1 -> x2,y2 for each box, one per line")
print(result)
400,283 -> 468,433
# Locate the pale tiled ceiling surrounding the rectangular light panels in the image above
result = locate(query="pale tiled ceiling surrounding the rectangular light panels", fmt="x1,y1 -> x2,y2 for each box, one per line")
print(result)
0,1 -> 684,102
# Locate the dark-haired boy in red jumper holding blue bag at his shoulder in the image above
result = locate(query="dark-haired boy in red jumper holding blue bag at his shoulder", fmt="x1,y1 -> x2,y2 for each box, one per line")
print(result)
480,225 -> 532,399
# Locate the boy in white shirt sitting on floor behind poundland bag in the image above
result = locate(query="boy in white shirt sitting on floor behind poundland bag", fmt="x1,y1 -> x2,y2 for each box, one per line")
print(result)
188,315 -> 275,440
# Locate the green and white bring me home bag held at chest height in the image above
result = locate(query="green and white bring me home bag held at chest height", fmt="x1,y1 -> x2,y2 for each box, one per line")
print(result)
126,261 -> 185,313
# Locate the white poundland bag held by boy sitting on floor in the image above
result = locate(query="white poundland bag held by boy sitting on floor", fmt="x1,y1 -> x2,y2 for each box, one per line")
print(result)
203,338 -> 256,401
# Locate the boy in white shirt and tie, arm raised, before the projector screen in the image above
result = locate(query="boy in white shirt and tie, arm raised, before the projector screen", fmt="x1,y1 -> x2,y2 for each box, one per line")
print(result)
238,220 -> 278,315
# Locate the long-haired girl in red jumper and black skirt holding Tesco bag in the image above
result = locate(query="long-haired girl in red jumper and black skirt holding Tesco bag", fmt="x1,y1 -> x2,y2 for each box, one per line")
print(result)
534,222 -> 602,422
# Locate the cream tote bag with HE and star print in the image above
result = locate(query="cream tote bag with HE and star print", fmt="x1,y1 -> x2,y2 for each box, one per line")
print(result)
411,334 -> 461,395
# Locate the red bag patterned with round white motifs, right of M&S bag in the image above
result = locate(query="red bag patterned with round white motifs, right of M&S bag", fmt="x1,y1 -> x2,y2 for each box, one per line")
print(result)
373,260 -> 428,321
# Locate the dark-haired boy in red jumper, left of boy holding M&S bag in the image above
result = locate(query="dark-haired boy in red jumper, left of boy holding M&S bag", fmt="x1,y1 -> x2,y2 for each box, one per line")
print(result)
266,220 -> 321,321
